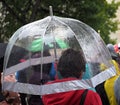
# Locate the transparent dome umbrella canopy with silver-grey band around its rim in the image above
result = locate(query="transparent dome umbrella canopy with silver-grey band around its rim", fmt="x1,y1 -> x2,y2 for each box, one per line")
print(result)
3,8 -> 116,95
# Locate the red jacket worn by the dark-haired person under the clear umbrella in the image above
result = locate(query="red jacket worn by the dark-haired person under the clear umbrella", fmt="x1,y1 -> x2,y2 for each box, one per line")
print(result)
42,78 -> 102,105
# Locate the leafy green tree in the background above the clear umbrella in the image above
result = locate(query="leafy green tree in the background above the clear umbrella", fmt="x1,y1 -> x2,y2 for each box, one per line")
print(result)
0,0 -> 120,44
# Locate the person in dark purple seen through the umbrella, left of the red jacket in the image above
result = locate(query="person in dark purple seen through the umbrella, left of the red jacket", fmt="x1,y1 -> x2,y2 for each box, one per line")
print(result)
28,50 -> 52,105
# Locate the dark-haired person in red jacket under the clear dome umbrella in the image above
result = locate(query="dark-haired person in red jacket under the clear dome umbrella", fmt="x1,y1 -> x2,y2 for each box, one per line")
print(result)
42,48 -> 102,105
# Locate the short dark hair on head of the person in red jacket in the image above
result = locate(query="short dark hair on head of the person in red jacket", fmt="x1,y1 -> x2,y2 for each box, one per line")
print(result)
57,48 -> 86,78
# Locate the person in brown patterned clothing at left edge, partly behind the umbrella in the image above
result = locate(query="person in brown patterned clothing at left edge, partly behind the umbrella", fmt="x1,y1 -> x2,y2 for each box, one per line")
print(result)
0,58 -> 21,105
